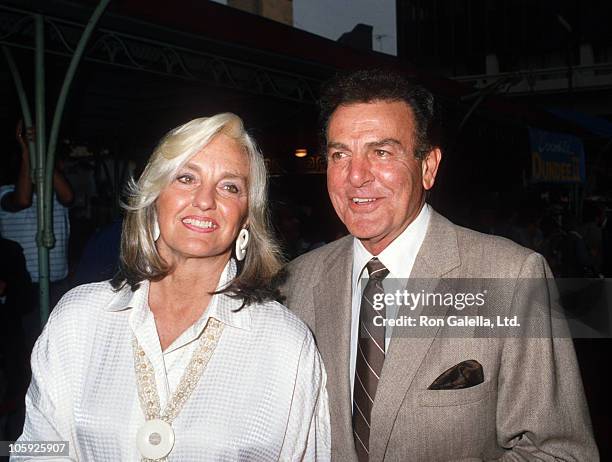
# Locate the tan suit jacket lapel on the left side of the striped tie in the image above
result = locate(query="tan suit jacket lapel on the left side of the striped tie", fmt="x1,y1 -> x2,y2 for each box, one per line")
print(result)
313,238 -> 354,456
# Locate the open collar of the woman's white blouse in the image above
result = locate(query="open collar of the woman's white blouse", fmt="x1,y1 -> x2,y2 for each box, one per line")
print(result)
106,259 -> 251,329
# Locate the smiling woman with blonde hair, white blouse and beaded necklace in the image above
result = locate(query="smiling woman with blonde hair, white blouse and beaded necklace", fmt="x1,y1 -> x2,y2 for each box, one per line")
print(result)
16,114 -> 330,462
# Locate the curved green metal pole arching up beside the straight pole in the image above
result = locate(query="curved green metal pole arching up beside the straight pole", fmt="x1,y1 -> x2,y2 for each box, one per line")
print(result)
43,0 -> 110,253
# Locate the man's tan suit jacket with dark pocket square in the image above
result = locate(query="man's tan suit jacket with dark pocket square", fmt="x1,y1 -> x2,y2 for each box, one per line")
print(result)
283,212 -> 599,462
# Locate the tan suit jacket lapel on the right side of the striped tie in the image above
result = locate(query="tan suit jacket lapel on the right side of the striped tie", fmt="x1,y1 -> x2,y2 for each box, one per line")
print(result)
370,210 -> 461,461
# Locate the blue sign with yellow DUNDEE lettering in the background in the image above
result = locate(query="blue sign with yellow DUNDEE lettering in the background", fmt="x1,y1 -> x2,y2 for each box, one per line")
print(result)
529,128 -> 586,183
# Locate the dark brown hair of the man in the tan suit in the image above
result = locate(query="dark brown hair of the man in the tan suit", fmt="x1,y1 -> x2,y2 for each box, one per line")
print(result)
319,69 -> 441,159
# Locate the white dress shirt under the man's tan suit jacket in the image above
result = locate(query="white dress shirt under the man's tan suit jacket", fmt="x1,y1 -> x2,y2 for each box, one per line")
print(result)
350,204 -> 431,402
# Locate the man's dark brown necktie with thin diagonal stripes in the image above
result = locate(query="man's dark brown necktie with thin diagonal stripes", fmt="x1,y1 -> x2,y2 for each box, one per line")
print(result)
353,257 -> 389,462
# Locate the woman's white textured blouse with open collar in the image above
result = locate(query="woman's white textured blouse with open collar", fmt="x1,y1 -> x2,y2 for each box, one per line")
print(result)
14,261 -> 330,462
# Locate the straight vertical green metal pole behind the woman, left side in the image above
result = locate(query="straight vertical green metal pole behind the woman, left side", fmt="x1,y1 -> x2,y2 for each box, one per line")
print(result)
34,14 -> 49,326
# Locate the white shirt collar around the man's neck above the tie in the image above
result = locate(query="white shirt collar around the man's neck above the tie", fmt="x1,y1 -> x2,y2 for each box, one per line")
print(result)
353,204 -> 431,287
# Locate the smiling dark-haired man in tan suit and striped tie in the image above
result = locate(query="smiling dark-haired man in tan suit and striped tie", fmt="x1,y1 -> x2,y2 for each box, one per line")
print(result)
283,70 -> 598,462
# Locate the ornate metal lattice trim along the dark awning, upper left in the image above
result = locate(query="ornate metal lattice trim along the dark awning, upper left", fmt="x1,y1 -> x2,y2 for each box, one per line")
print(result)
0,6 -> 321,104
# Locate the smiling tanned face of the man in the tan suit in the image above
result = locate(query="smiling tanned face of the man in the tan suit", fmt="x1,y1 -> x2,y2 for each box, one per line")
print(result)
327,101 -> 441,255
